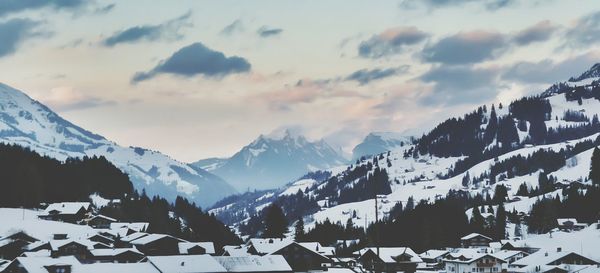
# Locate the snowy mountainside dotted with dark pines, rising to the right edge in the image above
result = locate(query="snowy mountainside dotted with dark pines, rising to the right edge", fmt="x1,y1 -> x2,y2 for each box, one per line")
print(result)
211,65 -> 600,234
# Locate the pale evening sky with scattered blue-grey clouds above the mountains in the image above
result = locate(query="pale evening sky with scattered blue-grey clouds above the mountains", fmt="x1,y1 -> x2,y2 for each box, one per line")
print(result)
0,0 -> 600,162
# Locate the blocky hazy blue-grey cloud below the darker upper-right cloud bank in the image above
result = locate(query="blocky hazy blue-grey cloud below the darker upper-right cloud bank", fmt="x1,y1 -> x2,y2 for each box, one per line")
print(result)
420,65 -> 500,105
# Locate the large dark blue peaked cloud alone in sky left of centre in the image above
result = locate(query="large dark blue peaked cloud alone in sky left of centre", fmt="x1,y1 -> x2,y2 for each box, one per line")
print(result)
132,43 -> 251,83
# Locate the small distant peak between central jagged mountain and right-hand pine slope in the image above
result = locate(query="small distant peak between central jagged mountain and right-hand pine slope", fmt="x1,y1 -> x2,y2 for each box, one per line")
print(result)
352,132 -> 414,159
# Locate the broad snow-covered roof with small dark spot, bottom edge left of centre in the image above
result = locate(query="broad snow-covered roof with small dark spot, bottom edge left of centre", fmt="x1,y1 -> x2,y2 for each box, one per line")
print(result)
148,255 -> 227,273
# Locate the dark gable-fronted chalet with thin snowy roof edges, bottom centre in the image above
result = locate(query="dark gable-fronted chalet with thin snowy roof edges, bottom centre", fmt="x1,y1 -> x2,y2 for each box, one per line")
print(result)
269,241 -> 332,272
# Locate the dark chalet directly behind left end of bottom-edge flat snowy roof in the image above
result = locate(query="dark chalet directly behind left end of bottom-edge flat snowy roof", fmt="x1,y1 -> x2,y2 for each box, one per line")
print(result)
129,234 -> 185,256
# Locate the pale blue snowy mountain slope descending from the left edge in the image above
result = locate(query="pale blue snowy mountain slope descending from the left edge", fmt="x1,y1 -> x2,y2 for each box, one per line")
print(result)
0,84 -> 235,206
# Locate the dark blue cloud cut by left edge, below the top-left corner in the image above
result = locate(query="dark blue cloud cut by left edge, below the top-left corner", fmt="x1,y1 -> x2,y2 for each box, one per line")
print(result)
0,19 -> 41,57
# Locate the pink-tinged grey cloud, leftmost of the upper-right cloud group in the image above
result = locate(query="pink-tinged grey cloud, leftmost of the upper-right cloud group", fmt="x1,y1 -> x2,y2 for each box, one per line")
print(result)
358,27 -> 429,59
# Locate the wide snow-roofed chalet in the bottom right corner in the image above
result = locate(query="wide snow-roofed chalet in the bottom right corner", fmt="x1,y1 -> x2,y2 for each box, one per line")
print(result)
509,245 -> 599,272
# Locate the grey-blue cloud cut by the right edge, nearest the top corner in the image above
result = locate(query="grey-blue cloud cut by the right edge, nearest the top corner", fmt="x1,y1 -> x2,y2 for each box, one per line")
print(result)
565,11 -> 600,48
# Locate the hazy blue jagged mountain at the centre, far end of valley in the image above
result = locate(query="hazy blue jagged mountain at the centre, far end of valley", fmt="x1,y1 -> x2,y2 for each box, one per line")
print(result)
192,130 -> 346,191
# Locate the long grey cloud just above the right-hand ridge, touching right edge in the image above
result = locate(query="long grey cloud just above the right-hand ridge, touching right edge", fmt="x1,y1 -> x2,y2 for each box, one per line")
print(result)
502,52 -> 600,84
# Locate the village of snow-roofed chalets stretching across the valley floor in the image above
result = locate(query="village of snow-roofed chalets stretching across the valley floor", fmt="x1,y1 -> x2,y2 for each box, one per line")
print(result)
0,202 -> 600,273
